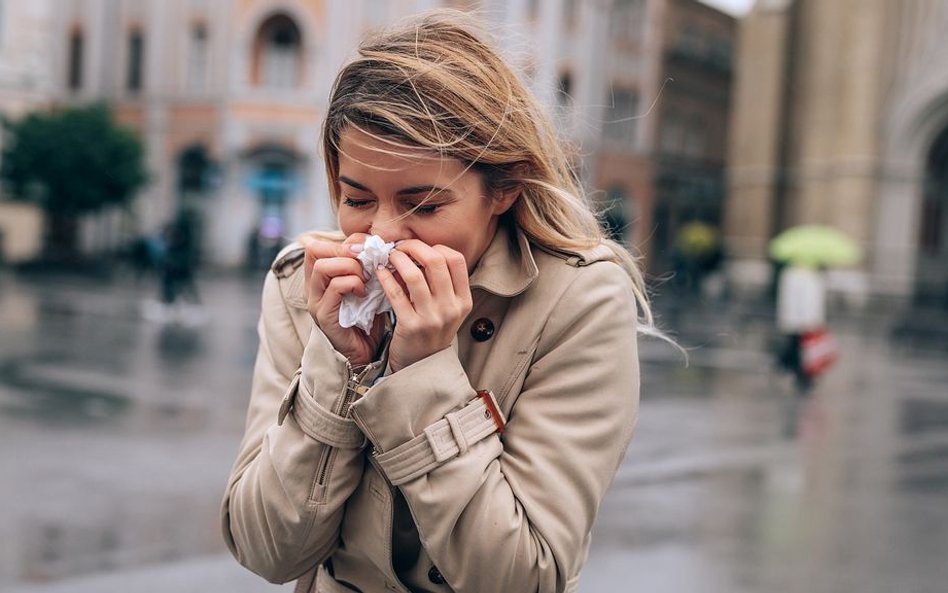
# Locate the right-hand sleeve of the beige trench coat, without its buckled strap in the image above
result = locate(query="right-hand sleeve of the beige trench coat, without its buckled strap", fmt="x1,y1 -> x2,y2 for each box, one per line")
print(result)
353,262 -> 639,593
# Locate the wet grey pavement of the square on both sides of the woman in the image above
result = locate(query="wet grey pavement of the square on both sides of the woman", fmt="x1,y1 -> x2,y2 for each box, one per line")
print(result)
0,269 -> 948,593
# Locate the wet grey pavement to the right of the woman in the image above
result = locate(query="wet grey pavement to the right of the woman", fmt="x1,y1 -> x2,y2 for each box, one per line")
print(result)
582,300 -> 948,593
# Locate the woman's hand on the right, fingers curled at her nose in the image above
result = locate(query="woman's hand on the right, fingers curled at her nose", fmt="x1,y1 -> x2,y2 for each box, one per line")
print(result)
378,239 -> 473,372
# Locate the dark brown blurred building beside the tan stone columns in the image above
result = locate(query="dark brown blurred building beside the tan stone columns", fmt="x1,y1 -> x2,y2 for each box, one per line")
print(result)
648,0 -> 737,271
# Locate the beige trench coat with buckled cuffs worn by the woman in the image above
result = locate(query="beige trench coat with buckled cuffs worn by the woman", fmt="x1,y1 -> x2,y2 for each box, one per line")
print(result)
222,223 -> 639,593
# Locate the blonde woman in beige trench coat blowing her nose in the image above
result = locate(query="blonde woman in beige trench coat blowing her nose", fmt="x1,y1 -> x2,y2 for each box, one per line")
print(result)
223,12 -> 651,593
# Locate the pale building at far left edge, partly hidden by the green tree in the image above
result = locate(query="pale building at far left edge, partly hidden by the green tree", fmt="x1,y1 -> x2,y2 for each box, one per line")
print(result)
0,0 -> 54,263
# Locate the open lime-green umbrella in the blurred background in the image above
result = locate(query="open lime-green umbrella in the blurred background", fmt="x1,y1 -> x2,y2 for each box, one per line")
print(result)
770,224 -> 862,267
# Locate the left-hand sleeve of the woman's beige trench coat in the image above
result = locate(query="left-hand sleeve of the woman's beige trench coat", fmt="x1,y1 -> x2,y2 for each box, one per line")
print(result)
221,272 -> 365,583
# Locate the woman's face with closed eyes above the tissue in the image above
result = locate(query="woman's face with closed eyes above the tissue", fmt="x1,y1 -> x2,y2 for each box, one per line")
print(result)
337,128 -> 516,272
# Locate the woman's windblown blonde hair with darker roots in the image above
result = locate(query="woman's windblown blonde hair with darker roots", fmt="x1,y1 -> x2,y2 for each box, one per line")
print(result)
322,10 -> 657,333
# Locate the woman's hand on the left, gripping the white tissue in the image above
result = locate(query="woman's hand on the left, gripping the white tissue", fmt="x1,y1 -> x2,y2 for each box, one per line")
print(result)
302,233 -> 384,366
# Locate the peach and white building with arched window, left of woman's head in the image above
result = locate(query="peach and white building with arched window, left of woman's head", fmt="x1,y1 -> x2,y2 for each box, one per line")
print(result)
55,0 -> 358,265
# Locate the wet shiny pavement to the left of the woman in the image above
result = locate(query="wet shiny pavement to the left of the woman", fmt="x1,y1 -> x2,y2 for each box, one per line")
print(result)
0,276 -> 259,590
